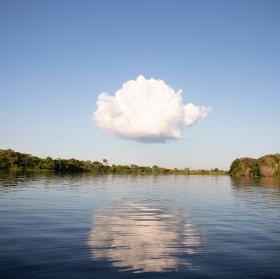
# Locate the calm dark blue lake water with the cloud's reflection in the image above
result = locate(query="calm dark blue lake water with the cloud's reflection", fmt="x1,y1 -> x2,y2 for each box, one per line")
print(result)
0,173 -> 280,279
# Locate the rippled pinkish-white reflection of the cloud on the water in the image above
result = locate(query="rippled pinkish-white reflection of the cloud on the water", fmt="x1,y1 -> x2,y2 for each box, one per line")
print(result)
88,204 -> 202,272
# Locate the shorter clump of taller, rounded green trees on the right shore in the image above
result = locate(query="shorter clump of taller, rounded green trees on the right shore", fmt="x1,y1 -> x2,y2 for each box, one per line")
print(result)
229,154 -> 280,177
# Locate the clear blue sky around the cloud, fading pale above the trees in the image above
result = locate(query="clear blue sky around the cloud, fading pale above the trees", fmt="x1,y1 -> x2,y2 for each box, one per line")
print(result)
0,0 -> 280,169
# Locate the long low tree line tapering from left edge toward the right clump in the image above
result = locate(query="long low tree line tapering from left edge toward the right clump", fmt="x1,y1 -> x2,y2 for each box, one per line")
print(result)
0,149 -> 227,175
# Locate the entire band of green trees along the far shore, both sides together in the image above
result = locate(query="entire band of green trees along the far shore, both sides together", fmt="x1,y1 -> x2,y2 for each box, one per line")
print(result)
0,149 -> 280,178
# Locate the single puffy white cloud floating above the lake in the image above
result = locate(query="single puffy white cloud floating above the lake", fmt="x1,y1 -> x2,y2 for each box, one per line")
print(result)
94,75 -> 210,142
